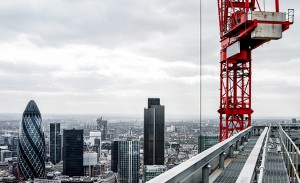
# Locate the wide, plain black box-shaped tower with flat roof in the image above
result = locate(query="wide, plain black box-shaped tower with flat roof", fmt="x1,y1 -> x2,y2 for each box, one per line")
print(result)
63,129 -> 83,177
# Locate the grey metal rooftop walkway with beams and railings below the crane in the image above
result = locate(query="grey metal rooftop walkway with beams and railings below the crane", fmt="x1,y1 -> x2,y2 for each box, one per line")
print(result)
148,123 -> 300,183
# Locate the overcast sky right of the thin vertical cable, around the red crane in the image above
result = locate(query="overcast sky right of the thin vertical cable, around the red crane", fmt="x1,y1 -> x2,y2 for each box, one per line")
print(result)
201,0 -> 300,118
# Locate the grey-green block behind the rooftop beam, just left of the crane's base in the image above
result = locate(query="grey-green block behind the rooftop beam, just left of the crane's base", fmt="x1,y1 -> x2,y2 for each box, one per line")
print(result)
198,135 -> 219,153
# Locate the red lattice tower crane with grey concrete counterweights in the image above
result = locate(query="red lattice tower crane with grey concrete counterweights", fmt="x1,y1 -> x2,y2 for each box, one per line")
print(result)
217,0 -> 294,142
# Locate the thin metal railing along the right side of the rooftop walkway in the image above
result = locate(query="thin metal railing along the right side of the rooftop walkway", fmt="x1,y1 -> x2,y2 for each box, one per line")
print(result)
279,124 -> 300,183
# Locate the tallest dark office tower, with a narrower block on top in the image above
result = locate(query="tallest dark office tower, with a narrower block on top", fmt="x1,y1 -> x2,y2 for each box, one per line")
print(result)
144,98 -> 165,165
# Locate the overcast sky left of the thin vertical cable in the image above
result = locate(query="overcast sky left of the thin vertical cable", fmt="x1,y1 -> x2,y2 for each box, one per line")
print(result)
0,0 -> 202,116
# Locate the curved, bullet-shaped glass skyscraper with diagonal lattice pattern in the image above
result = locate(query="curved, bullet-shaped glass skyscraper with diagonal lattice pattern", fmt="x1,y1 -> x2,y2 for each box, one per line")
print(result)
18,100 -> 46,180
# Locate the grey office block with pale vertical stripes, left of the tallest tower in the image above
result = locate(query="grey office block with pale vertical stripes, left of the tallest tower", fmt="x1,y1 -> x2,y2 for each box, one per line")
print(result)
118,140 -> 140,183
